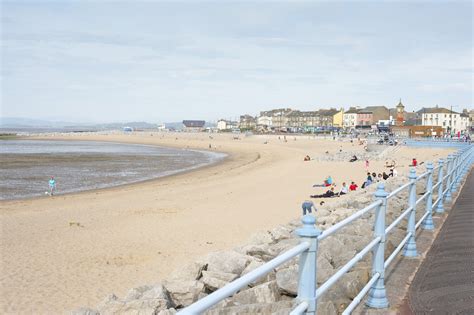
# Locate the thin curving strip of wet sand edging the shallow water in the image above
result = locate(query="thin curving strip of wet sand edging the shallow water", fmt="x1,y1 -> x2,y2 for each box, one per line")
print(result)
0,136 -> 230,206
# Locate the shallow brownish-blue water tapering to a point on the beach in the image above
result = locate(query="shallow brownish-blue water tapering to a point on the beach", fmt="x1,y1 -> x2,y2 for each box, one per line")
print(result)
0,140 -> 225,200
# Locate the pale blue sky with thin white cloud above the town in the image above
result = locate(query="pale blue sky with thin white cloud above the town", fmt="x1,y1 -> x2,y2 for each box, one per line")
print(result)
0,0 -> 474,123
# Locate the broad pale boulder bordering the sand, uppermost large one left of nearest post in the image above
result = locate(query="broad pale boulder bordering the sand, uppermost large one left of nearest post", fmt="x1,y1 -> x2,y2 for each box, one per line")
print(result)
203,251 -> 253,275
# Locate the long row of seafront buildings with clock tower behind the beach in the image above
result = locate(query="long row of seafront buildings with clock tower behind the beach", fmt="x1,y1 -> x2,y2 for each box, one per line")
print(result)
207,99 -> 474,136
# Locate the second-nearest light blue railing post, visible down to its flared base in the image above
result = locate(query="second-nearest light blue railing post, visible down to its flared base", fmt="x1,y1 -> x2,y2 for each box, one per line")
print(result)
366,183 -> 388,308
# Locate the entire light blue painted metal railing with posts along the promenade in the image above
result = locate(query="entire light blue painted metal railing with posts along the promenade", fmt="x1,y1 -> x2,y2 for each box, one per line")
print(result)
178,145 -> 474,315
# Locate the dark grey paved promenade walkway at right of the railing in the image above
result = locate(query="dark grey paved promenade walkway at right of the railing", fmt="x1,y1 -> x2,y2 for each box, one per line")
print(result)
408,171 -> 474,314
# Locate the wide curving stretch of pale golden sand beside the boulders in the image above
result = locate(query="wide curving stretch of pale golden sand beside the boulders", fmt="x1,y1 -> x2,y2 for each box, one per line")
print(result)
0,132 -> 452,314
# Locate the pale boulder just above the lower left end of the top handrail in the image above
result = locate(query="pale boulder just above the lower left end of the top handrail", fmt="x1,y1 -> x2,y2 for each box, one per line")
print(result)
164,280 -> 204,307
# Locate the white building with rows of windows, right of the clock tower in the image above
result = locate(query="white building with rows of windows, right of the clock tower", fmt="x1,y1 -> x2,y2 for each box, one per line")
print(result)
421,107 -> 469,133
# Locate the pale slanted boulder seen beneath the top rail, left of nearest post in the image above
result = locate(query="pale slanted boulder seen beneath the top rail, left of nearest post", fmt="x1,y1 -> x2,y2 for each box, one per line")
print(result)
232,281 -> 280,305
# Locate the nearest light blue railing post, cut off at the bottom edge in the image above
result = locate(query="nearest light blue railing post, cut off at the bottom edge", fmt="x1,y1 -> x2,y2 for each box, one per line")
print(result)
296,214 -> 321,315
